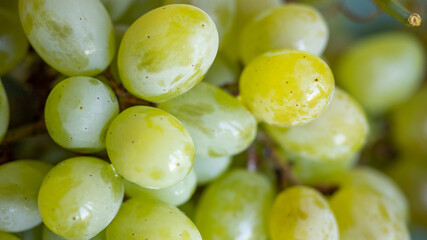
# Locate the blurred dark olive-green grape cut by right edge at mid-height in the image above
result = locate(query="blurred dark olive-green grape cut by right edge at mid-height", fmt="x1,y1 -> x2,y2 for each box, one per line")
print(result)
391,86 -> 427,157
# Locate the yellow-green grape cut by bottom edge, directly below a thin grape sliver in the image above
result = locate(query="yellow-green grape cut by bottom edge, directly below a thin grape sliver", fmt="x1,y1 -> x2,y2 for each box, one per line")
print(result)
107,198 -> 202,240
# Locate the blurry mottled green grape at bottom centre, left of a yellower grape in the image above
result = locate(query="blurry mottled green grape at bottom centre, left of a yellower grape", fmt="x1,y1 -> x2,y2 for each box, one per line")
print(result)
195,170 -> 273,240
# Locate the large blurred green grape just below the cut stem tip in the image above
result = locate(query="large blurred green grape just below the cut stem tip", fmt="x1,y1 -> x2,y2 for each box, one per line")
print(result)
335,32 -> 426,115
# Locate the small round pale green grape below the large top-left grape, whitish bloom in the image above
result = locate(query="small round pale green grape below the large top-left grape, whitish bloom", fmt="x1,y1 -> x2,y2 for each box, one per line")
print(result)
45,77 -> 119,153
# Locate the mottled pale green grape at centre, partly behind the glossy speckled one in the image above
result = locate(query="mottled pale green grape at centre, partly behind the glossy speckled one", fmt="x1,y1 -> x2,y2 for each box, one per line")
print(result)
158,82 -> 257,157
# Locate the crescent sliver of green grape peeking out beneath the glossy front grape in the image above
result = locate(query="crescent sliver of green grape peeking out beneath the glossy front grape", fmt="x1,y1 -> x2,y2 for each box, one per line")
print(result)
125,171 -> 197,206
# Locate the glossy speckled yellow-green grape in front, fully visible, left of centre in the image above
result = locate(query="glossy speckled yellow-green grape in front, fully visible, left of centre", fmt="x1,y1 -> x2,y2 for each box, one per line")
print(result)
107,106 -> 194,189
